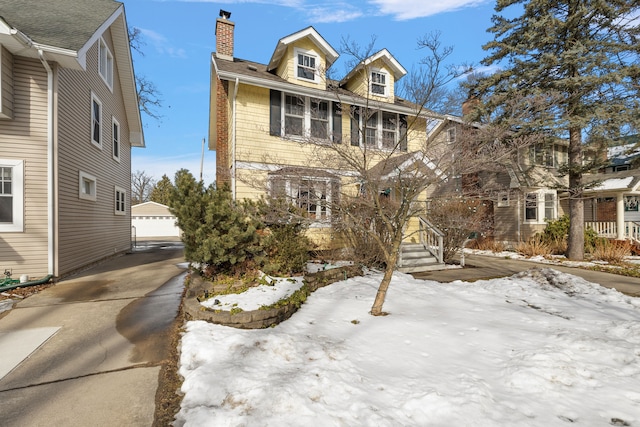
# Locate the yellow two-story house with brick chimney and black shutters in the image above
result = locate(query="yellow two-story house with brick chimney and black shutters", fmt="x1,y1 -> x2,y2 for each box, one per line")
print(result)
209,10 -> 442,272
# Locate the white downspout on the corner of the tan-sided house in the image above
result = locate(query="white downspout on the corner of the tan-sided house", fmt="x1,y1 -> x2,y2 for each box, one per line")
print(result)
38,49 -> 55,275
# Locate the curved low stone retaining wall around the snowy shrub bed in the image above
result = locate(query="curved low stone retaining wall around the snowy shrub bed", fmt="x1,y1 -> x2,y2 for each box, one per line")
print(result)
182,266 -> 362,329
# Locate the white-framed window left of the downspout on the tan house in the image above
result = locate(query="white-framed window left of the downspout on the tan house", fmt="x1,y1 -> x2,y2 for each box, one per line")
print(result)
0,159 -> 24,232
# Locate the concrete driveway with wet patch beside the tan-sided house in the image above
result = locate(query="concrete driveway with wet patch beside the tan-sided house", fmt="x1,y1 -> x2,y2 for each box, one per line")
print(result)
0,242 -> 186,427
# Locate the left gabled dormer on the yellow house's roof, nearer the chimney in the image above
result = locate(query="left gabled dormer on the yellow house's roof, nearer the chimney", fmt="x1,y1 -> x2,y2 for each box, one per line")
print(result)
267,27 -> 338,90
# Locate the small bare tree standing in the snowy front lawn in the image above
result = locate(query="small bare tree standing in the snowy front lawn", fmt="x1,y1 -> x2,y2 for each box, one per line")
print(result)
239,33 -> 478,316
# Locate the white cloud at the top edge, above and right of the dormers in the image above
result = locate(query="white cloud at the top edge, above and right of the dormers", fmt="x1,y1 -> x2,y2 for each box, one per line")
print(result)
369,0 -> 487,21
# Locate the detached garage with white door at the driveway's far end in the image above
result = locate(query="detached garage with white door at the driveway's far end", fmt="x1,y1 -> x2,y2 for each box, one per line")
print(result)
131,202 -> 181,240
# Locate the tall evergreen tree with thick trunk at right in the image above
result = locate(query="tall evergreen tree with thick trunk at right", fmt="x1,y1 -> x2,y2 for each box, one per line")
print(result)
476,0 -> 640,259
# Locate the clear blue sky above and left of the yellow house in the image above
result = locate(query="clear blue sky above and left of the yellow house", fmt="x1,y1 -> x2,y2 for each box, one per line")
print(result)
121,0 -> 495,184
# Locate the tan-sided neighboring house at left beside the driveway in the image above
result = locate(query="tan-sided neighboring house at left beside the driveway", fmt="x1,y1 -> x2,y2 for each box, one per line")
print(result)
0,0 -> 144,277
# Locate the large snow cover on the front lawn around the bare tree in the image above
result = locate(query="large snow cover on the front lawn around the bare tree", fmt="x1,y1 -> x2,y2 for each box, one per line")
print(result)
175,268 -> 640,427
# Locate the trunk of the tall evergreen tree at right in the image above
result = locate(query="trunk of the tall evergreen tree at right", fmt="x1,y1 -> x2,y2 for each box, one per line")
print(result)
567,127 -> 584,261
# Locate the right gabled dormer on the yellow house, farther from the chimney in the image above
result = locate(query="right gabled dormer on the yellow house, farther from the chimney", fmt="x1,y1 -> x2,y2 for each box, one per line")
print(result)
340,49 -> 407,102
